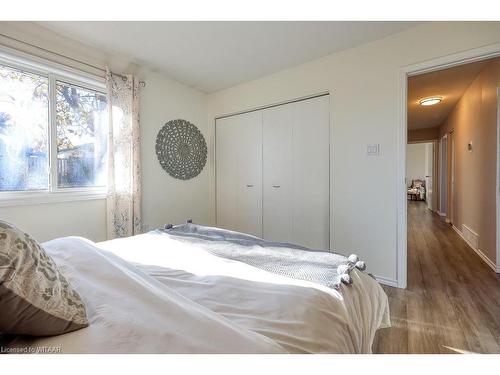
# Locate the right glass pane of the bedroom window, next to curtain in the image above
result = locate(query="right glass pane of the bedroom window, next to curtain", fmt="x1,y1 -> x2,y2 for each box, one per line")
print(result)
56,82 -> 107,188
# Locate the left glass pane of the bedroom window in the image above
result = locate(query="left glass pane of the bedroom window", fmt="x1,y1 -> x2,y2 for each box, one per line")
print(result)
0,65 -> 49,191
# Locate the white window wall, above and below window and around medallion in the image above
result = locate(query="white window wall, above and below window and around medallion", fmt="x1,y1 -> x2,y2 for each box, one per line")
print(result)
0,22 -> 210,241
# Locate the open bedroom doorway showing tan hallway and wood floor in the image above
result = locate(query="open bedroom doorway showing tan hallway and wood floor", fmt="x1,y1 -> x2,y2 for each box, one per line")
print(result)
380,51 -> 500,353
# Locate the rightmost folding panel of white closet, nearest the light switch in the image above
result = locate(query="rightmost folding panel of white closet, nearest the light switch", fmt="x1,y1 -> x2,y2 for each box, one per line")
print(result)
291,96 -> 330,250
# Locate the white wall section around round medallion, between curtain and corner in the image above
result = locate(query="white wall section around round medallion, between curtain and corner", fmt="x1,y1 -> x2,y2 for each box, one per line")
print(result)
139,71 -> 210,229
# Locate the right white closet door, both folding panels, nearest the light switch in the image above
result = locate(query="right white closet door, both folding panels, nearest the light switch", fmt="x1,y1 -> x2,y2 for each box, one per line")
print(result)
262,96 -> 330,250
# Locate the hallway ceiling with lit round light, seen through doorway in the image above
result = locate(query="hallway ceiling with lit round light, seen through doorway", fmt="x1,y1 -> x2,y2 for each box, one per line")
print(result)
408,60 -> 491,129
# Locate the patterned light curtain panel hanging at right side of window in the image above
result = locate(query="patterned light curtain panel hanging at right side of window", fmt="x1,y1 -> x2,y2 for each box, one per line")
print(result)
106,69 -> 141,239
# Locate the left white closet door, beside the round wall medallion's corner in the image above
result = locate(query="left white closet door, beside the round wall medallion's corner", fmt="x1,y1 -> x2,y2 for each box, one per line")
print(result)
216,112 -> 262,237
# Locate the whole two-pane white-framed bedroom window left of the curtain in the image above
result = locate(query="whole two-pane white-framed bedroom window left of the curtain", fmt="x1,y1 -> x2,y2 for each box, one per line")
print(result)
0,53 -> 108,204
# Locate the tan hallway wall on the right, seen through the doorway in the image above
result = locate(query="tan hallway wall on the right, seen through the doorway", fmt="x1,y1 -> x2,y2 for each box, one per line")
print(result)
440,58 -> 500,262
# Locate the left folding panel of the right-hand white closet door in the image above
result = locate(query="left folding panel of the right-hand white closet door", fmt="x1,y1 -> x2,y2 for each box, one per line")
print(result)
262,104 -> 293,242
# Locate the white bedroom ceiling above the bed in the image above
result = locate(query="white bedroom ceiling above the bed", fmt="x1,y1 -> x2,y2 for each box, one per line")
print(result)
39,21 -> 420,93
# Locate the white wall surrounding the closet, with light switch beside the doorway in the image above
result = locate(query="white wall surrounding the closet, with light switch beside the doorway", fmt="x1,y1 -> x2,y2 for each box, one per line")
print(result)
208,22 -> 500,283
